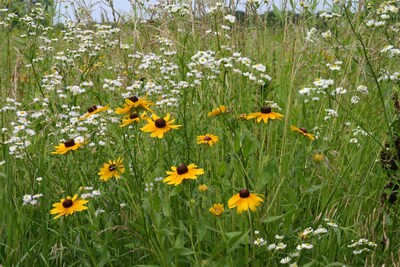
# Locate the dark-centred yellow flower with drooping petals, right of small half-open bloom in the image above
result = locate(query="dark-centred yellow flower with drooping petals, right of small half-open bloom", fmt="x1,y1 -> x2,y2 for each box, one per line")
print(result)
228,189 -> 264,214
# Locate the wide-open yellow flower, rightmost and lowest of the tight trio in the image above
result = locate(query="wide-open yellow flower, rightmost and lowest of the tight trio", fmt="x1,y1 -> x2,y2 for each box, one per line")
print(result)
140,113 -> 181,138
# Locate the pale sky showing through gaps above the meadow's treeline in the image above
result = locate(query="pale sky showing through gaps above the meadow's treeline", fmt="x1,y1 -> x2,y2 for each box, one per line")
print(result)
56,0 -> 332,21
